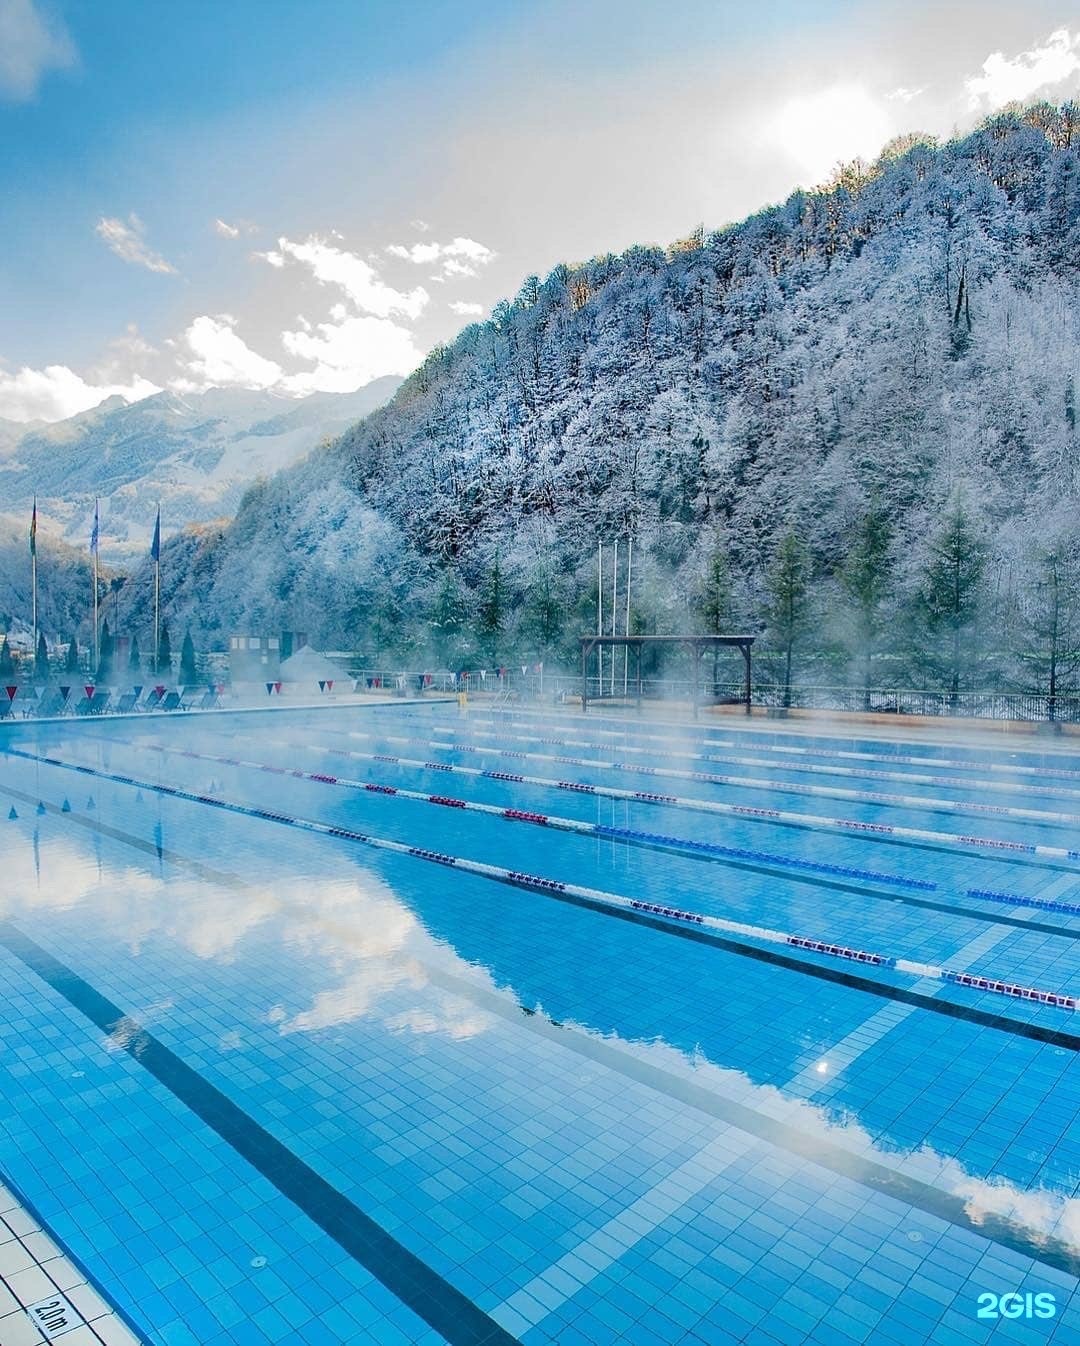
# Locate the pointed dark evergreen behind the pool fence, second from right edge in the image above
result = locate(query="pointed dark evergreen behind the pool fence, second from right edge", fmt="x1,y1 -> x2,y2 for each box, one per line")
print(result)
920,502 -> 987,709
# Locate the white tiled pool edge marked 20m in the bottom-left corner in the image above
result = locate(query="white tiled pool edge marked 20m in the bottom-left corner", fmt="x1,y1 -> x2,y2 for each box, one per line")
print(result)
0,1183 -> 143,1346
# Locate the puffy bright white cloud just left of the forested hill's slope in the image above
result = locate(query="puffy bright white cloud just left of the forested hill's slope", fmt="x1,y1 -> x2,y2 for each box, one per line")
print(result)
281,313 -> 423,393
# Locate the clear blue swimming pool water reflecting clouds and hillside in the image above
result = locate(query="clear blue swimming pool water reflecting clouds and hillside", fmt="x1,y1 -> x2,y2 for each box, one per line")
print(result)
0,704 -> 1080,1346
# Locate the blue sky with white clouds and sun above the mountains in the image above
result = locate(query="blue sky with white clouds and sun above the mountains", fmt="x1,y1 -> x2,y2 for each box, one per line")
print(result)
0,0 -> 1080,420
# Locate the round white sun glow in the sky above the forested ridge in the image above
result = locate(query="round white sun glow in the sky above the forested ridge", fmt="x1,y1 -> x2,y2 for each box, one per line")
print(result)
768,85 -> 891,186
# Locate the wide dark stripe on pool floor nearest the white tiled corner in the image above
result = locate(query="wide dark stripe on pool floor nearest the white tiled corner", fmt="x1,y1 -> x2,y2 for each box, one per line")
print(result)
0,919 -> 516,1346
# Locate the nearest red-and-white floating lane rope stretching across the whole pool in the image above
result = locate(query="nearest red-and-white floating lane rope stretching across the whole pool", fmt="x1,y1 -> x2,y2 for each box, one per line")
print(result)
3,747 -> 1077,1012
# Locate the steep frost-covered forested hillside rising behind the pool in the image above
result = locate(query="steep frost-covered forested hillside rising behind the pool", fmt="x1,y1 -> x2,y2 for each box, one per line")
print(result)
126,105 -> 1080,686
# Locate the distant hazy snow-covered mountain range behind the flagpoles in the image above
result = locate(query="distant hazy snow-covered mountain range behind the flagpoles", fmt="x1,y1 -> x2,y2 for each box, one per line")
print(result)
0,378 -> 400,564
